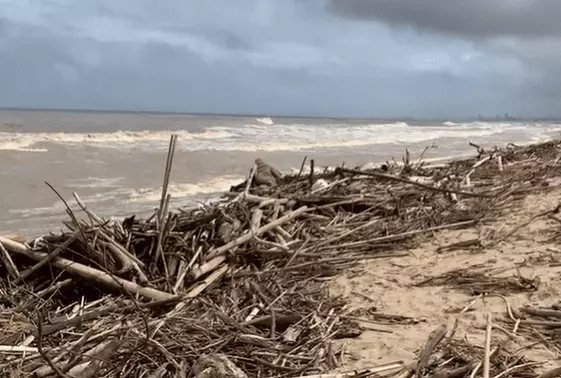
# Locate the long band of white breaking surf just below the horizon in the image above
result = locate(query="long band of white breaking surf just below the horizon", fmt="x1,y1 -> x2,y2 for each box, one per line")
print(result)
0,123 -> 561,152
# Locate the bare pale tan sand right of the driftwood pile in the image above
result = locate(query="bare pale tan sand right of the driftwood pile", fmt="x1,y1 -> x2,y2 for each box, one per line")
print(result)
330,188 -> 561,370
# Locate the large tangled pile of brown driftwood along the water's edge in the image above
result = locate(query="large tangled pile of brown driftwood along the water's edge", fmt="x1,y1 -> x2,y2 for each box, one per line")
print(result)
0,139 -> 561,377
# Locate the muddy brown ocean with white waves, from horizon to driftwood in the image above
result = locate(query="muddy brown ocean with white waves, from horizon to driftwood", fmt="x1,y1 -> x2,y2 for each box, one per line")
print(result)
0,110 -> 561,237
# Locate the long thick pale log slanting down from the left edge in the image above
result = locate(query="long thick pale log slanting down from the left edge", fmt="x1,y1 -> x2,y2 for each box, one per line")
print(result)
0,236 -> 174,300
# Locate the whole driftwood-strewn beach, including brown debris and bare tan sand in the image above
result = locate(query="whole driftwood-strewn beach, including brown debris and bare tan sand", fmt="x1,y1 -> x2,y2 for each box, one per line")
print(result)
0,137 -> 561,378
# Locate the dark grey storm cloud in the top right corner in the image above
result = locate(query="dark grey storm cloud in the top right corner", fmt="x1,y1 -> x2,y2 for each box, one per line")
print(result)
330,0 -> 561,38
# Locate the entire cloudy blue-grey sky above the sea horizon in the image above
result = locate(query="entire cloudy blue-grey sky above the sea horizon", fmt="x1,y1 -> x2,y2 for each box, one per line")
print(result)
0,0 -> 561,117
